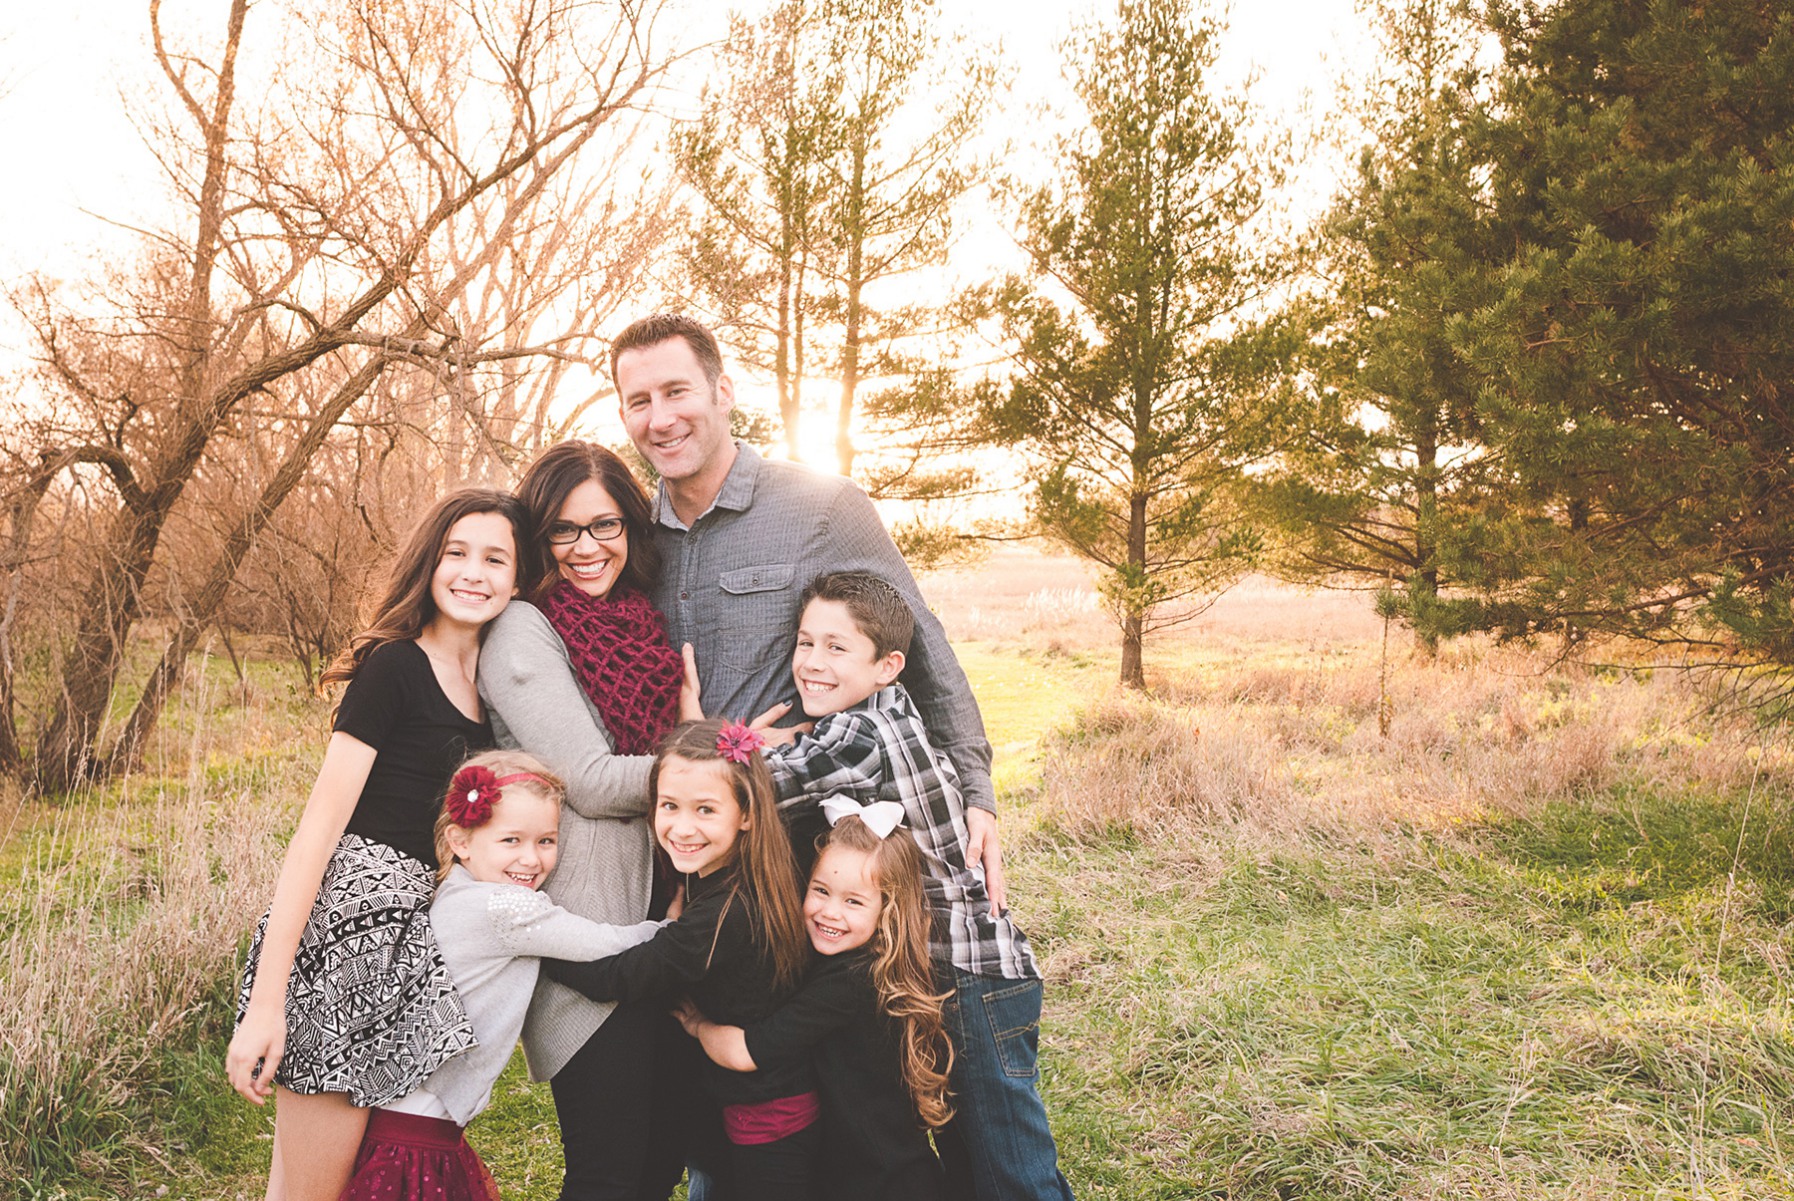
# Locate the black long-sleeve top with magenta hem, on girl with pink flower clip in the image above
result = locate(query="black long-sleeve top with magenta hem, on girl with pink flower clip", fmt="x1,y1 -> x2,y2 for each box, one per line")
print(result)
542,869 -> 816,1106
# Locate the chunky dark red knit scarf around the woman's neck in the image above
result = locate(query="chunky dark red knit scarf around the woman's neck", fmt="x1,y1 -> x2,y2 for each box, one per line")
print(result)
538,580 -> 685,754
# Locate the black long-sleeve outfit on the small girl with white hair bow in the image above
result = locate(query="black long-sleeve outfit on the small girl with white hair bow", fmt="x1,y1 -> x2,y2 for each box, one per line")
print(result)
739,948 -> 945,1201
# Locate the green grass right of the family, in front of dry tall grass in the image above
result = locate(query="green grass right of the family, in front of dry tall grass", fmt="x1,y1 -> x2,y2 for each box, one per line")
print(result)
1014,795 -> 1794,1199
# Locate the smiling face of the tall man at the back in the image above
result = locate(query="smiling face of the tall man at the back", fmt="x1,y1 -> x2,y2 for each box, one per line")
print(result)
617,338 -> 736,483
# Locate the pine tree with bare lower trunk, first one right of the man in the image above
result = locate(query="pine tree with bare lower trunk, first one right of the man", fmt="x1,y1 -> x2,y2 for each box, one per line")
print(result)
992,0 -> 1281,688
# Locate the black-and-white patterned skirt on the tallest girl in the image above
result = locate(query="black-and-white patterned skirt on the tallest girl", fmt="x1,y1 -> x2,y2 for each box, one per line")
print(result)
237,835 -> 475,1106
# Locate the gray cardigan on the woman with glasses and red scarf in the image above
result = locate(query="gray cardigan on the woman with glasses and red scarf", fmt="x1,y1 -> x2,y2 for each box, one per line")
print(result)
479,601 -> 653,1081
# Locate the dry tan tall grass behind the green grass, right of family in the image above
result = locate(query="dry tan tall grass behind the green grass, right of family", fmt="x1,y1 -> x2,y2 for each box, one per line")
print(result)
1042,643 -> 1794,840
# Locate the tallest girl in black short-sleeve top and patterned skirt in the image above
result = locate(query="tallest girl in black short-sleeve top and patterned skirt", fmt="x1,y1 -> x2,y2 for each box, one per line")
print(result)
224,488 -> 526,1201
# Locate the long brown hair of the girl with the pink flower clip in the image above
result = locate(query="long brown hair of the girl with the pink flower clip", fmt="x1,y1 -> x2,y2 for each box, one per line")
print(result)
648,718 -> 809,995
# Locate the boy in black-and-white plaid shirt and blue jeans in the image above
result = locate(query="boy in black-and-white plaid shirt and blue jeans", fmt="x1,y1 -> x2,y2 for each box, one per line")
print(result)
766,571 -> 1071,1201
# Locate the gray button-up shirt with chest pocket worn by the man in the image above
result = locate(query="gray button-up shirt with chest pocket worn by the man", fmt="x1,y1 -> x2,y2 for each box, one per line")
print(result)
653,443 -> 996,810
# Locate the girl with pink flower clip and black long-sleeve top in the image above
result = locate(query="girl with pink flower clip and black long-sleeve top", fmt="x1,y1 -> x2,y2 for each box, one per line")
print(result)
544,720 -> 820,1201
